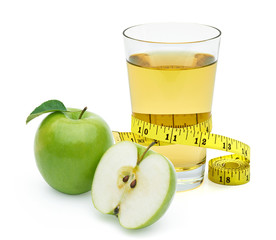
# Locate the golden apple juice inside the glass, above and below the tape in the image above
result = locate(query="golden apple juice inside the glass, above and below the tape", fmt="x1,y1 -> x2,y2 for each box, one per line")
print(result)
127,52 -> 217,171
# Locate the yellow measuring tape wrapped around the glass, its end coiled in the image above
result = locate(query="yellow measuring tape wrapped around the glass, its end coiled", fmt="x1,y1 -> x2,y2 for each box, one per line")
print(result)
113,116 -> 250,185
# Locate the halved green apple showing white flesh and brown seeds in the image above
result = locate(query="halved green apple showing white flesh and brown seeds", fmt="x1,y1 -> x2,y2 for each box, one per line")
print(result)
91,141 -> 176,229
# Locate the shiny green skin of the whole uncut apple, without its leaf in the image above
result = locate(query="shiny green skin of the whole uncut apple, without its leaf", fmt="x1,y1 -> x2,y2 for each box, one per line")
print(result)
34,109 -> 113,194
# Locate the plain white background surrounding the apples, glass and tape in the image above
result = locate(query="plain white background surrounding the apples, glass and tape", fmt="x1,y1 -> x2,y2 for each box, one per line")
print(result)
0,0 -> 276,240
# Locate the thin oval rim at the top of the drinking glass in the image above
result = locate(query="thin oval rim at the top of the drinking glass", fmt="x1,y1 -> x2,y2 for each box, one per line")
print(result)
123,22 -> 221,44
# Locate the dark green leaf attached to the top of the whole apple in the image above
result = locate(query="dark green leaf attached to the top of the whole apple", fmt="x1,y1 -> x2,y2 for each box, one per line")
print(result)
26,100 -> 67,124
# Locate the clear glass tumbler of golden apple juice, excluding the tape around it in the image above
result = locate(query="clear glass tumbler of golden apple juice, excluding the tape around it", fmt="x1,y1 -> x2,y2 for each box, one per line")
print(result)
123,23 -> 221,191
